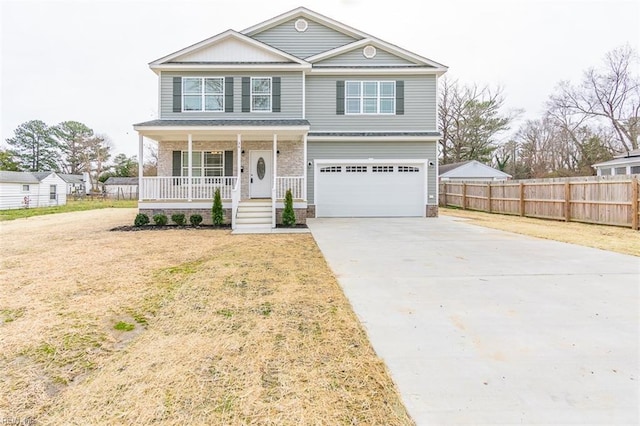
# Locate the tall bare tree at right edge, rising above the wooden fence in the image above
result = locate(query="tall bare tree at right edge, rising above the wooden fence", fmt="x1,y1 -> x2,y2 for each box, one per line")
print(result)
549,46 -> 640,151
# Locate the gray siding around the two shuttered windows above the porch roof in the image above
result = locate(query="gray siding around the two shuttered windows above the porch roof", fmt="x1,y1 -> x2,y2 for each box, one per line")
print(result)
160,71 -> 302,120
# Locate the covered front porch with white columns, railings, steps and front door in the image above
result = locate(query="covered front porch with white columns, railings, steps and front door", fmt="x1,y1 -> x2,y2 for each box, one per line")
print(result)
134,120 -> 309,229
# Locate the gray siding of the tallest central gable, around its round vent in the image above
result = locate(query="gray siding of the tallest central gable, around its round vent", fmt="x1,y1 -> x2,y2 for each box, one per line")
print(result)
251,17 -> 359,59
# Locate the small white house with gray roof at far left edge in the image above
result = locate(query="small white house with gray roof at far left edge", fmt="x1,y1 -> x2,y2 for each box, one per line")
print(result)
0,171 -> 67,210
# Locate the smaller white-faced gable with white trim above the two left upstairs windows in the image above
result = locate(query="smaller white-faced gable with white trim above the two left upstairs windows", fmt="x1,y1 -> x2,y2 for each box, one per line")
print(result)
149,30 -> 309,71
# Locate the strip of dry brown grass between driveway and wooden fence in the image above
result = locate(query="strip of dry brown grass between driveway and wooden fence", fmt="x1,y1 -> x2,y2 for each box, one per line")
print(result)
440,208 -> 640,256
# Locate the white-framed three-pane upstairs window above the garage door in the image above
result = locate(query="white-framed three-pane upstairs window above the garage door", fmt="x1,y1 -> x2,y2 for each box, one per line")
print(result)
345,81 -> 396,114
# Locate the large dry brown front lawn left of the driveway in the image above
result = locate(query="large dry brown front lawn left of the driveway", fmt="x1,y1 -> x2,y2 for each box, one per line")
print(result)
0,209 -> 413,425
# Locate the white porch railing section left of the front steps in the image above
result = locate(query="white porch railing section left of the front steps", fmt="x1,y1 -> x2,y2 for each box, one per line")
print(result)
140,176 -> 238,200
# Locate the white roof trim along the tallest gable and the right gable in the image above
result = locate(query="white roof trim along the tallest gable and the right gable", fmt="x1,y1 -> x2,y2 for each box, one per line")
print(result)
242,7 -> 447,73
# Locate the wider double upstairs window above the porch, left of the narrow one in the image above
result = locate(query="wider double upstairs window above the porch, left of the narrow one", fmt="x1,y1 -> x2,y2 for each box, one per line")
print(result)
182,77 -> 224,111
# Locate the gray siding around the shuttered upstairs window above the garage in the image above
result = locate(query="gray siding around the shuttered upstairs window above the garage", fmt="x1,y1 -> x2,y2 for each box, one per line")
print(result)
306,75 -> 437,132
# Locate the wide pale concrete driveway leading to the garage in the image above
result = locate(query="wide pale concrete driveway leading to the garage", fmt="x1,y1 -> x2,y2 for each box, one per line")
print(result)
308,217 -> 640,425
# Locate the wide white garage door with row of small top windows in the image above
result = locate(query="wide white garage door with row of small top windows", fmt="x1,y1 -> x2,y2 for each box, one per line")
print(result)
315,160 -> 426,217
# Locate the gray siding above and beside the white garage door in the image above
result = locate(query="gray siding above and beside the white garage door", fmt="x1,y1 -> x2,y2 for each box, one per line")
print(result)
307,141 -> 438,205
